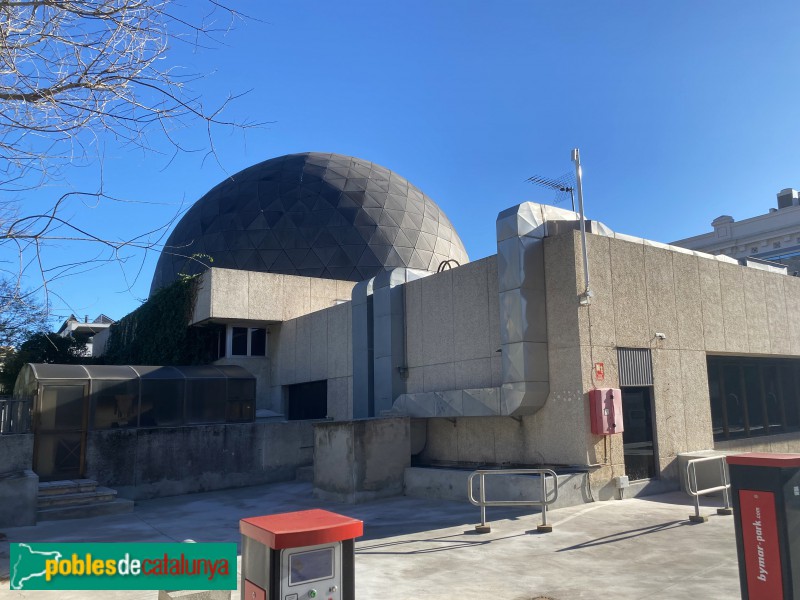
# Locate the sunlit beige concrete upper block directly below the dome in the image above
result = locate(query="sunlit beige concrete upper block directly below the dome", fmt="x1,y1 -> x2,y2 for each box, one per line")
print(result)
191,268 -> 355,325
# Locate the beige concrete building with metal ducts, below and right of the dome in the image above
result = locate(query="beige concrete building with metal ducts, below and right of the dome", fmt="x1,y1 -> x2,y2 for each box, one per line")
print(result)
184,203 -> 800,498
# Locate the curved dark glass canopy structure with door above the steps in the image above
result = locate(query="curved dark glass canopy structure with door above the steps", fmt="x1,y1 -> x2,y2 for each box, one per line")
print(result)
13,364 -> 256,480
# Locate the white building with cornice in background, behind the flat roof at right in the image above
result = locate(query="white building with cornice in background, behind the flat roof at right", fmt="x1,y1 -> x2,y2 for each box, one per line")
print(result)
672,188 -> 800,275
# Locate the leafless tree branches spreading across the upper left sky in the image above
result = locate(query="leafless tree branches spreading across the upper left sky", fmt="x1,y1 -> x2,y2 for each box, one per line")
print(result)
0,0 -> 257,308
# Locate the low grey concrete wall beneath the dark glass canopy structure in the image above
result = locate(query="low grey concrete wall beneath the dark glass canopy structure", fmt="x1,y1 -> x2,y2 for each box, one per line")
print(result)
86,421 -> 313,500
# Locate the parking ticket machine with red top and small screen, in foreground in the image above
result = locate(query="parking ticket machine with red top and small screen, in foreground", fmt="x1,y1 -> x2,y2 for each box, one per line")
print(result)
239,509 -> 364,600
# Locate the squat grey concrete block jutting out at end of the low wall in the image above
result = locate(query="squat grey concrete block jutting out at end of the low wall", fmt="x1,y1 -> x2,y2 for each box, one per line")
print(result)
314,417 -> 411,503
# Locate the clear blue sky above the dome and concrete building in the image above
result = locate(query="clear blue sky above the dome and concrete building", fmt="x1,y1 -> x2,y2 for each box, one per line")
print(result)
14,0 -> 800,326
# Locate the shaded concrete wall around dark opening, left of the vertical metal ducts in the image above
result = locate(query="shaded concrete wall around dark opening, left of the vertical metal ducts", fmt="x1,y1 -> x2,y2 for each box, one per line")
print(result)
269,303 -> 353,420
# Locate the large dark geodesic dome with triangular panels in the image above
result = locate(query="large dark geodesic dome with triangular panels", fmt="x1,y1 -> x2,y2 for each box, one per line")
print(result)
151,152 -> 469,293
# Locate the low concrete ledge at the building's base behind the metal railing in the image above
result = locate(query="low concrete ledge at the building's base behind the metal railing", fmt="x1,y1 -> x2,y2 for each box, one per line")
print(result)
404,467 -> 592,508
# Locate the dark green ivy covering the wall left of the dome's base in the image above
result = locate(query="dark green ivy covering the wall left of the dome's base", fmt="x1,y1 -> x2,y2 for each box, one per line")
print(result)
102,276 -> 219,366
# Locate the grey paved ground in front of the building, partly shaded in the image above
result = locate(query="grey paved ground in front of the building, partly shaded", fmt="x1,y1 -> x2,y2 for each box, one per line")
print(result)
0,482 -> 739,600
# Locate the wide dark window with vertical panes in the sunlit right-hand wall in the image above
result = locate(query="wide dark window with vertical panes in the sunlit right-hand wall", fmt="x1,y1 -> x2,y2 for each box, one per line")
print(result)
708,356 -> 800,441
